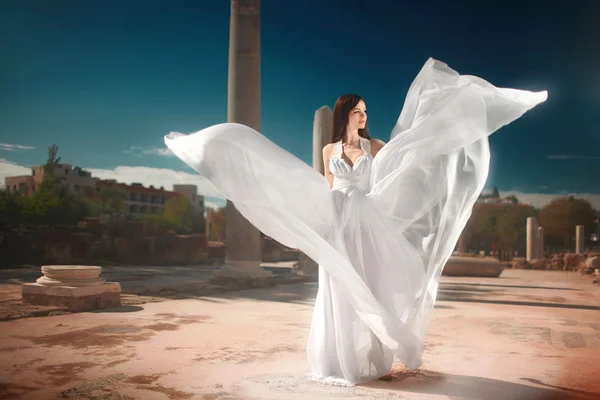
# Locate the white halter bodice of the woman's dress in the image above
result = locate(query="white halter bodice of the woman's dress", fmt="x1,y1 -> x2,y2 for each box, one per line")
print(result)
329,137 -> 373,191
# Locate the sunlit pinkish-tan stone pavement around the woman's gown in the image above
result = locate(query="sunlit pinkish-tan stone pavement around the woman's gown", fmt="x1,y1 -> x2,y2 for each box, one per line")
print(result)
0,270 -> 600,400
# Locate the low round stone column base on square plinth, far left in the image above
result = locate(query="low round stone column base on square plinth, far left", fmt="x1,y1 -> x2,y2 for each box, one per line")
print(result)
21,265 -> 121,311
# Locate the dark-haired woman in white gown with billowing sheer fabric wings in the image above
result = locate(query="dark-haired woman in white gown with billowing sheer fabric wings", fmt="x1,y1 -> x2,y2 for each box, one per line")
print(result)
165,59 -> 547,385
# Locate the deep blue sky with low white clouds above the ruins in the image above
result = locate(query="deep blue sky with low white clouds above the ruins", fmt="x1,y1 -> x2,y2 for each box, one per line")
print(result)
0,0 -> 600,207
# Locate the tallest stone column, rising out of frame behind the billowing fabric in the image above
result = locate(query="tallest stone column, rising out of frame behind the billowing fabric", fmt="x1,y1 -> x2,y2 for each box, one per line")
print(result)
213,0 -> 272,286
